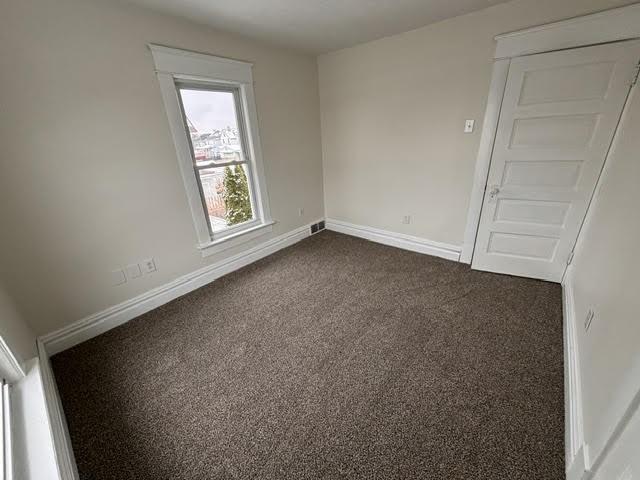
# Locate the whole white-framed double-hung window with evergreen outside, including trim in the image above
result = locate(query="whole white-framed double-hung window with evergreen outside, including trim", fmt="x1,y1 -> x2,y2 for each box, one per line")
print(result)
150,45 -> 273,256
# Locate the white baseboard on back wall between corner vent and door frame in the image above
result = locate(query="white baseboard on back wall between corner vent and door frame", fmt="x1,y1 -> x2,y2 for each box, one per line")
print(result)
326,218 -> 461,262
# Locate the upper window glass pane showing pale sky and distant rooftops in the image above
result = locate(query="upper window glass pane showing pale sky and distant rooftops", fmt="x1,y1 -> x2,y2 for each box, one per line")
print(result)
179,88 -> 243,166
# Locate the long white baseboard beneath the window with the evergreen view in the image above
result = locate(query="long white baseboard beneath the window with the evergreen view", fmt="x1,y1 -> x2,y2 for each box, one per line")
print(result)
40,220 -> 319,355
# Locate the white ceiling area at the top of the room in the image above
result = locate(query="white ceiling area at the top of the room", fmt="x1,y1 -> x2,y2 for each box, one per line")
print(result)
122,0 -> 507,53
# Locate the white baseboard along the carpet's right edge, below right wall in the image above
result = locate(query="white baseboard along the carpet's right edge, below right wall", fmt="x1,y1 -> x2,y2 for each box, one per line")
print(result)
562,282 -> 589,480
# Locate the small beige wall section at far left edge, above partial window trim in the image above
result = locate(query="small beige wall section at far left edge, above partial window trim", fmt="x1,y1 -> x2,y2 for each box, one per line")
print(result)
0,284 -> 36,364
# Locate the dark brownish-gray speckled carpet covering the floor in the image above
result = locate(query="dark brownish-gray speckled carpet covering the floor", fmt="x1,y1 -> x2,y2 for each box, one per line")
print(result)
53,232 -> 564,480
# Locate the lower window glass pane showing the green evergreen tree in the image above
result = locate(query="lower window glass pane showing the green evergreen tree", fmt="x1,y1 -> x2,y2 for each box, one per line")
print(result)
197,165 -> 255,233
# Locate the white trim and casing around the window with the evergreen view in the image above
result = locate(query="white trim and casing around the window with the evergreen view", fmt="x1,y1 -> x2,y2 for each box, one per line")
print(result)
149,45 -> 274,257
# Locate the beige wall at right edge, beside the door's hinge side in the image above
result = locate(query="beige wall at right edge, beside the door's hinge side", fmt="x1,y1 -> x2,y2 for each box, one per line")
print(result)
566,87 -> 640,468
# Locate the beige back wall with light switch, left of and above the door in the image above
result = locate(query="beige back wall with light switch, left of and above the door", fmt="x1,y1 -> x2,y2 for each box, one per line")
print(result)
318,0 -> 632,246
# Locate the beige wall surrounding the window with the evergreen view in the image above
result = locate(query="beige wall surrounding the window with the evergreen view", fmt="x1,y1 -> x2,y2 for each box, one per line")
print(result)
0,0 -> 323,334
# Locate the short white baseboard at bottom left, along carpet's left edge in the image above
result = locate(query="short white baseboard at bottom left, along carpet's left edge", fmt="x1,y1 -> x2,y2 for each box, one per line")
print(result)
37,340 -> 80,480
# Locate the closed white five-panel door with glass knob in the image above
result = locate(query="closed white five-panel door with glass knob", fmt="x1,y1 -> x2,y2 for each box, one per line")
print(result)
472,41 -> 640,282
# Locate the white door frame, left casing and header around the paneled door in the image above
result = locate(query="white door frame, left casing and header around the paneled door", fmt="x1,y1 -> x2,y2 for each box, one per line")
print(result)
460,3 -> 640,264
